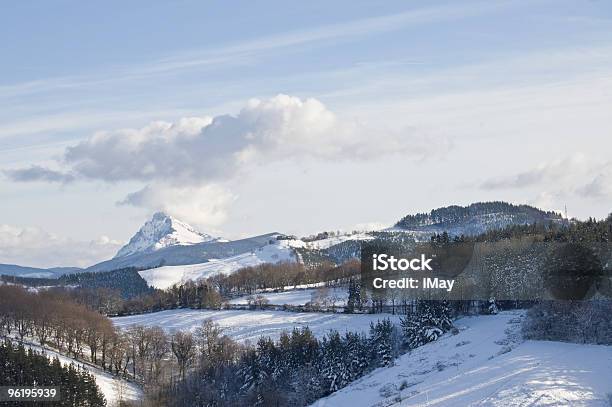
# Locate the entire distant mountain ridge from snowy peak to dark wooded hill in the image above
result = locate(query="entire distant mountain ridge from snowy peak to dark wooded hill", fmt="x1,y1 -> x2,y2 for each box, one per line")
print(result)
0,201 -> 564,277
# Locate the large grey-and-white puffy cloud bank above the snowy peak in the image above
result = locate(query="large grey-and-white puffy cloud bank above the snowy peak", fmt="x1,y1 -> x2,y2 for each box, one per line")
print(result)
4,95 -> 448,225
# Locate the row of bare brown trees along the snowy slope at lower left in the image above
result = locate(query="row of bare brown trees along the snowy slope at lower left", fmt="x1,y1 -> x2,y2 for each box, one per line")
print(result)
0,286 -> 171,390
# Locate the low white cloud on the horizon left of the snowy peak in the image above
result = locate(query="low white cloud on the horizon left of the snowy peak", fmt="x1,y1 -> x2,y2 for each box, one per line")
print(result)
0,224 -> 122,267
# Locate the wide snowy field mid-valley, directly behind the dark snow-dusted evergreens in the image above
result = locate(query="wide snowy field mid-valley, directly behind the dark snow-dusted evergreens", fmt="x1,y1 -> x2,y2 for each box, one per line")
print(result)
112,309 -> 398,343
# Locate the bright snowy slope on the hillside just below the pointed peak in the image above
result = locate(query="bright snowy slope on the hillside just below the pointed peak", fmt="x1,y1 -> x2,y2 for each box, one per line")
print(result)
139,240 -> 296,289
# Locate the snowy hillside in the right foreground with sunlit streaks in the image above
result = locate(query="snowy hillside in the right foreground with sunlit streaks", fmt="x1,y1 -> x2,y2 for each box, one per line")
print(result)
314,312 -> 612,407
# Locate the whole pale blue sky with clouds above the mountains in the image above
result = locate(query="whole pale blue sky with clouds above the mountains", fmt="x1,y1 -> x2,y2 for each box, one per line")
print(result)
0,0 -> 612,267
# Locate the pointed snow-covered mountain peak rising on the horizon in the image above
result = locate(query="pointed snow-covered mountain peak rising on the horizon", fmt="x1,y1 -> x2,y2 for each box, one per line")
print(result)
115,212 -> 215,258
